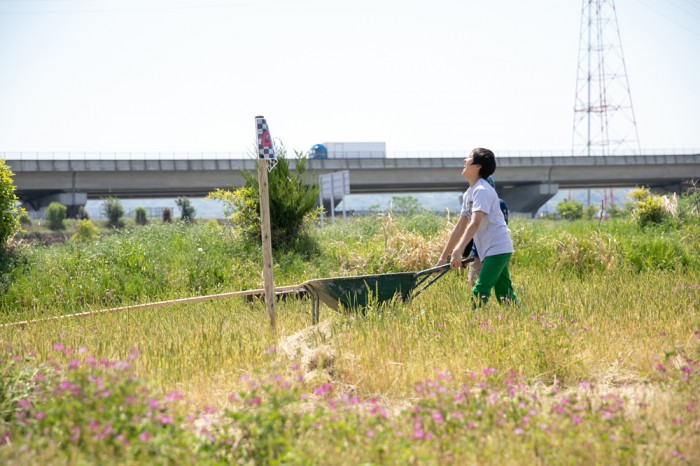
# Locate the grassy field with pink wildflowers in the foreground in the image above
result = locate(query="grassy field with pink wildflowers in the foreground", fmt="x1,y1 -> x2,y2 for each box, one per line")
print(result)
0,209 -> 700,464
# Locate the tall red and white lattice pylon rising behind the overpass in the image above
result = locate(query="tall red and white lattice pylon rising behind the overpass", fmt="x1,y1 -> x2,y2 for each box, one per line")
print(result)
572,0 -> 640,155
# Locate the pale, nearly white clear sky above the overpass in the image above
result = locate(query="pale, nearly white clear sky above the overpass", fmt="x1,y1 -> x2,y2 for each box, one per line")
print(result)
0,0 -> 700,152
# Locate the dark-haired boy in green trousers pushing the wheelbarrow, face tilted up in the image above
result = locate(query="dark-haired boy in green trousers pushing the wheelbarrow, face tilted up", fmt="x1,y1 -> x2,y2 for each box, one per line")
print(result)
437,147 -> 518,307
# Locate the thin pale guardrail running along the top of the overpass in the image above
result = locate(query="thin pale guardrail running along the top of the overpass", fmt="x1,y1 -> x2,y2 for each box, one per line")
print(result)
0,148 -> 700,161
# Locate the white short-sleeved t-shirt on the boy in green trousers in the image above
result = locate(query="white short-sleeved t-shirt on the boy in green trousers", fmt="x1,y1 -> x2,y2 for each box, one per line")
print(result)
460,178 -> 513,259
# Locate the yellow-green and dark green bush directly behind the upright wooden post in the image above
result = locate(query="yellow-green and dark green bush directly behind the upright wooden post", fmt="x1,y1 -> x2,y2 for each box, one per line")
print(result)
207,144 -> 319,245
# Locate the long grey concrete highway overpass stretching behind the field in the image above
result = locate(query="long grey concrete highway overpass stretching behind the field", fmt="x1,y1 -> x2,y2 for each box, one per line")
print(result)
5,151 -> 700,217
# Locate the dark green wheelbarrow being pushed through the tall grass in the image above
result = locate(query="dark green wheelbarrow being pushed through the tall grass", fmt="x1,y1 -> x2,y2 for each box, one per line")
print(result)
301,257 -> 474,324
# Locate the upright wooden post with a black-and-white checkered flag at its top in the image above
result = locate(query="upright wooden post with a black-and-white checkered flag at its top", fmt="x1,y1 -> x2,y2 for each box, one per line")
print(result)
255,116 -> 277,331
